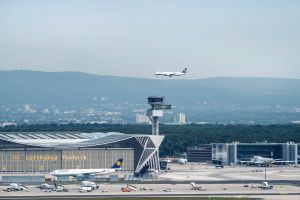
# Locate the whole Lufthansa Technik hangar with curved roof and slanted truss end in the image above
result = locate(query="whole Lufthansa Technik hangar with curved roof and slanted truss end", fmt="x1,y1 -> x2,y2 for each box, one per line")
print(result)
0,132 -> 164,174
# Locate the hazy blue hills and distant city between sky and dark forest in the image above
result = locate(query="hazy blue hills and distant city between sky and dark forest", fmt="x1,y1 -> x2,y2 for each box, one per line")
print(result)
0,71 -> 300,124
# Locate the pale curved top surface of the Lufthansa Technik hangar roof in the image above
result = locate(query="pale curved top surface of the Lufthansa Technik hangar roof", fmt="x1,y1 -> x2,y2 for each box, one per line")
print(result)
0,132 -> 134,147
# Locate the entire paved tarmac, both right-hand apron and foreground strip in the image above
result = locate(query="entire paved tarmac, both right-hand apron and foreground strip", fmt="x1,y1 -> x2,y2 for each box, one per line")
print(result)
0,163 -> 300,200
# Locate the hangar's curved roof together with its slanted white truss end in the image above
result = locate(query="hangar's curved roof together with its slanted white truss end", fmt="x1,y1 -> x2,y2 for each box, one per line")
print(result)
0,132 -> 164,173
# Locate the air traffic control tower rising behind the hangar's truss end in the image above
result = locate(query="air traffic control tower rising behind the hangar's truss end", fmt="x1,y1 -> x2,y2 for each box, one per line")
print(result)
147,96 -> 171,135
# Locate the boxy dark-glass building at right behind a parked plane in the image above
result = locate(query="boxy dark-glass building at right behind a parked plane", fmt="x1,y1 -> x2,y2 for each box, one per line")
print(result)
212,142 -> 299,165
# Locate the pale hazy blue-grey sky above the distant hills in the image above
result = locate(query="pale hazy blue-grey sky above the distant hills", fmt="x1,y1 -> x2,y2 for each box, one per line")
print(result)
0,0 -> 300,78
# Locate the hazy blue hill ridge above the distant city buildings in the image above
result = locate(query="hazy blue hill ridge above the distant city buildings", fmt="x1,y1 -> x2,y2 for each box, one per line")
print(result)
0,70 -> 300,106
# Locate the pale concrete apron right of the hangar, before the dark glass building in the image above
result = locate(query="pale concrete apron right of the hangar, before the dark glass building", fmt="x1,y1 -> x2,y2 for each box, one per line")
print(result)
159,163 -> 300,182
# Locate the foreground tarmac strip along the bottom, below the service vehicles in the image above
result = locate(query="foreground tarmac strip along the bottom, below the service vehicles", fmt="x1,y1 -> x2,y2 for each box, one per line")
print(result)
0,184 -> 300,199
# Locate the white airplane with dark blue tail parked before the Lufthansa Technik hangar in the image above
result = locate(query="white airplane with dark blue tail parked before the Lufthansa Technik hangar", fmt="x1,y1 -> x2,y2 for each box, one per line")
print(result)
50,158 -> 123,178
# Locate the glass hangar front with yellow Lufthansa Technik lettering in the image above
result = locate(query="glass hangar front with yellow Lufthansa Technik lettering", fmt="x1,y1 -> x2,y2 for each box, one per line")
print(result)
0,148 -> 134,172
